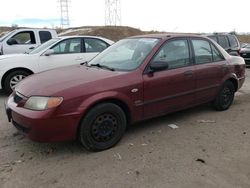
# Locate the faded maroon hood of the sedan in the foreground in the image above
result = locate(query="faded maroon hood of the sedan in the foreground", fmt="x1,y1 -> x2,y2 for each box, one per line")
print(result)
15,65 -> 124,97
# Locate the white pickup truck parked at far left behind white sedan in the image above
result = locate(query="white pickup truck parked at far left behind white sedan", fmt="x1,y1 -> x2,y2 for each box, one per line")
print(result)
0,28 -> 57,55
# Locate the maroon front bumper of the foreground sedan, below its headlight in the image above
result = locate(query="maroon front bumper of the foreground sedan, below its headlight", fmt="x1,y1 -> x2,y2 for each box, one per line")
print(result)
5,95 -> 81,142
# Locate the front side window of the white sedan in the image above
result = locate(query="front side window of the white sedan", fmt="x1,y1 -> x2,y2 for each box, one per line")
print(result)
52,38 -> 81,54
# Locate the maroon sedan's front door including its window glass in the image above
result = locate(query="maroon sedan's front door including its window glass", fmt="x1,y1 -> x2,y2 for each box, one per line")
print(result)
143,38 -> 195,118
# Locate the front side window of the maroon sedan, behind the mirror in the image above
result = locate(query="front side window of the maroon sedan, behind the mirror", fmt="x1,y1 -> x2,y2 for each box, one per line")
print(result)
152,40 -> 190,69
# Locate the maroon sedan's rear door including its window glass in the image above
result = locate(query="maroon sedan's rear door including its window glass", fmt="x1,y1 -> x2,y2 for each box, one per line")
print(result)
191,38 -> 229,103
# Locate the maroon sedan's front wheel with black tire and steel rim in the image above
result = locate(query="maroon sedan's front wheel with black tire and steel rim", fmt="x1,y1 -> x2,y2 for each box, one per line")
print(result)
79,103 -> 127,151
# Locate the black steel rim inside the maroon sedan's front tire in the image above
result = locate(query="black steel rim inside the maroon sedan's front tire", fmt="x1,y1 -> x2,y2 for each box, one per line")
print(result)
91,114 -> 118,142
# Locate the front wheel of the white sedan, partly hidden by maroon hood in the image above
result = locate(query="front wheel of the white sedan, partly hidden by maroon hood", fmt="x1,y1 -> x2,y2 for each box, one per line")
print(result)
3,70 -> 30,94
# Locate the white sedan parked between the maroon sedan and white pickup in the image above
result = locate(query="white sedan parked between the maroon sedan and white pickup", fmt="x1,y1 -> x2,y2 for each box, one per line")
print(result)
0,36 -> 113,93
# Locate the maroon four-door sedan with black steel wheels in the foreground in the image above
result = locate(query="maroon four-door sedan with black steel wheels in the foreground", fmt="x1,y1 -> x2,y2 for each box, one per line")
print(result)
6,35 -> 245,151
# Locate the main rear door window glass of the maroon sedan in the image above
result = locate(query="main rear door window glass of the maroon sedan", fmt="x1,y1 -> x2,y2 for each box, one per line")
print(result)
192,39 -> 213,64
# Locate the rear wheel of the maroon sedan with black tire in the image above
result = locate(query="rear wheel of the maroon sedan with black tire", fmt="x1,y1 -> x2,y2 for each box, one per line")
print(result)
213,81 -> 235,111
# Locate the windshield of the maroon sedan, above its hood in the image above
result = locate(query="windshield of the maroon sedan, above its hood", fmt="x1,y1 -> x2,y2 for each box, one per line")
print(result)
88,38 -> 159,71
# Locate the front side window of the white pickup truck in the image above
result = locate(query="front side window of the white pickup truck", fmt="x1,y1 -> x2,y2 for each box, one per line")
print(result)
11,31 -> 36,44
